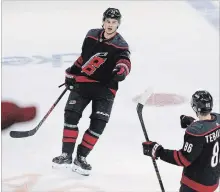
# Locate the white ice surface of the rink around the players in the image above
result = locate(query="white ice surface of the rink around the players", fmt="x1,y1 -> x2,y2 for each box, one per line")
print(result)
2,1 -> 220,192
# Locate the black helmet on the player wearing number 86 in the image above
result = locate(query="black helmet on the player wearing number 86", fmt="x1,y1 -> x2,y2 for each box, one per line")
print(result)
191,90 -> 213,114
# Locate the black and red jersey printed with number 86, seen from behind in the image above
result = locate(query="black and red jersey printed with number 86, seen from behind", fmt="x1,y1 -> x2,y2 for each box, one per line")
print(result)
160,113 -> 220,192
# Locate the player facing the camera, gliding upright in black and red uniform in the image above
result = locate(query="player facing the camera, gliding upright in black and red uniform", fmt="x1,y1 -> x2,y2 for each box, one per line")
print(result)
52,8 -> 131,175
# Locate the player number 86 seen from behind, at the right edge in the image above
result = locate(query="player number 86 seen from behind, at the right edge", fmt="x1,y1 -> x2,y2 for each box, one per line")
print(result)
142,91 -> 220,192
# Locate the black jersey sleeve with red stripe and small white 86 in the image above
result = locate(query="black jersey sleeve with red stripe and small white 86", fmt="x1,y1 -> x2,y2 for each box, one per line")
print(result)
160,132 -> 204,167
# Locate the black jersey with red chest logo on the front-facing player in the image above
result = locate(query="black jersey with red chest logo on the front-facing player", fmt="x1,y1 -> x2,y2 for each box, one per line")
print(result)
69,29 -> 131,90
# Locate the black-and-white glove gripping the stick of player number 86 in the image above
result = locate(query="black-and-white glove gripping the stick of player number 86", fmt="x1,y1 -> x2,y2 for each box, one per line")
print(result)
142,141 -> 163,159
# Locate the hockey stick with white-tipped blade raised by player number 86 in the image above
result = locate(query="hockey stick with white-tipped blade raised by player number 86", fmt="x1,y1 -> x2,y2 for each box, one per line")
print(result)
136,90 -> 165,192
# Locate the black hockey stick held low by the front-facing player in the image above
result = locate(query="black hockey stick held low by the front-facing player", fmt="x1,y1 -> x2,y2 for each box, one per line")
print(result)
10,88 -> 67,138
